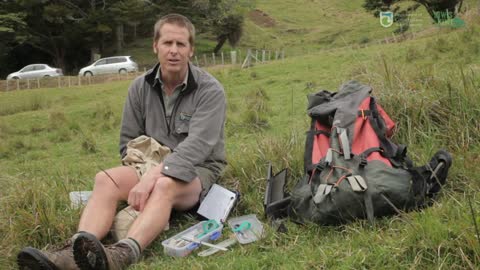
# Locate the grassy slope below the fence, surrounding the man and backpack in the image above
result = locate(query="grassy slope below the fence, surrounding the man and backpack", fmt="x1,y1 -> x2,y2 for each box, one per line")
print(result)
0,1 -> 480,269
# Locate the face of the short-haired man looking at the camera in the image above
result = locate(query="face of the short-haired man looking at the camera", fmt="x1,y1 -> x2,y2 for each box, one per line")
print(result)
153,23 -> 193,76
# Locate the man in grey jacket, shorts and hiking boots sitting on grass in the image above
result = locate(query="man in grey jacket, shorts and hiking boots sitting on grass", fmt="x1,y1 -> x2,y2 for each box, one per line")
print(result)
17,14 -> 226,269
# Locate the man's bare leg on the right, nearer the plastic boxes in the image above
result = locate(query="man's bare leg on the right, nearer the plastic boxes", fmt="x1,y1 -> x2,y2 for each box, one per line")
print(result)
127,177 -> 202,250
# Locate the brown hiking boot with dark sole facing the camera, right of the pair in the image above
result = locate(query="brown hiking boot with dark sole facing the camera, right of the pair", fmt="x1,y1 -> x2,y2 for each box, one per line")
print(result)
73,233 -> 136,270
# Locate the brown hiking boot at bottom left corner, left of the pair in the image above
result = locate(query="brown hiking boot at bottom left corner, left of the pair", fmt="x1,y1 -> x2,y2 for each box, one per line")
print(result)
17,240 -> 79,270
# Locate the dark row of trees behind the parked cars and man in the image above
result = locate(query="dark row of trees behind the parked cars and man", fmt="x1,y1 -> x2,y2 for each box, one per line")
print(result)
0,0 -> 253,76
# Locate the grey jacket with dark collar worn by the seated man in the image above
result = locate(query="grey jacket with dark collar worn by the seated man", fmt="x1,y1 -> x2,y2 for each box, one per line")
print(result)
120,64 -> 226,182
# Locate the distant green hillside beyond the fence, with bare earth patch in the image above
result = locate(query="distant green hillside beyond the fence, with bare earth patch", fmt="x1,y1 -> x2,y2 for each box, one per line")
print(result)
124,0 -> 478,66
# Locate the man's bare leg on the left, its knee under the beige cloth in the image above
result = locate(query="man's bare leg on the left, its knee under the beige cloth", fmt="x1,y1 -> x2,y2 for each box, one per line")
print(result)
78,166 -> 138,239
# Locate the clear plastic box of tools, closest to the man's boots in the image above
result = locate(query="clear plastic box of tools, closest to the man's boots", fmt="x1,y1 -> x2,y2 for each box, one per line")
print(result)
162,221 -> 223,257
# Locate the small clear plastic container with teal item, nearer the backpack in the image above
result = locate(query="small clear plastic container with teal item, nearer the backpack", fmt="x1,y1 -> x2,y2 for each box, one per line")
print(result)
228,214 -> 263,244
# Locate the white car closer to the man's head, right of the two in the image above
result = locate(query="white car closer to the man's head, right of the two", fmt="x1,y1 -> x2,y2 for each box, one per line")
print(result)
78,56 -> 138,76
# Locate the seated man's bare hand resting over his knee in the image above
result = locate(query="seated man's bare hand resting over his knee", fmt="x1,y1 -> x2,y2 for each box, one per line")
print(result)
128,164 -> 163,212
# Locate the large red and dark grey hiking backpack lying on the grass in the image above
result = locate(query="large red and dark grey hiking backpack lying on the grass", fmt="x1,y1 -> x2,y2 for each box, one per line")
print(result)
265,81 -> 452,225
